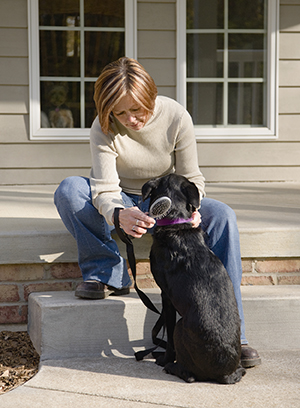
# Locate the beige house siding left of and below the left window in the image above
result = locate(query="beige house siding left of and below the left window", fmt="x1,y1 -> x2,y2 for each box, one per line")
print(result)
0,0 -> 90,185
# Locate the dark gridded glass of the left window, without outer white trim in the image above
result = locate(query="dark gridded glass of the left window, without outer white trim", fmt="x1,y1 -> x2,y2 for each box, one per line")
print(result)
39,0 -> 125,128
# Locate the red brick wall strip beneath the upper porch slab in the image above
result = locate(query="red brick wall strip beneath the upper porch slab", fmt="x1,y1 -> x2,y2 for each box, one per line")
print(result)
0,258 -> 300,331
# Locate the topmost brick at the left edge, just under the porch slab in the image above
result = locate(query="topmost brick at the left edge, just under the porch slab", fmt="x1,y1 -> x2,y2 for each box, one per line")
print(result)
0,264 -> 44,282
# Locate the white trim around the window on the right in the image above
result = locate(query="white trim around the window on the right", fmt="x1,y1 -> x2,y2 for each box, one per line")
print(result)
177,0 -> 279,140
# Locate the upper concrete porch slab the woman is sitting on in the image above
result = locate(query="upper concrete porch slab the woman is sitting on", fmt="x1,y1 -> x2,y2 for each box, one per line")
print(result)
0,182 -> 300,265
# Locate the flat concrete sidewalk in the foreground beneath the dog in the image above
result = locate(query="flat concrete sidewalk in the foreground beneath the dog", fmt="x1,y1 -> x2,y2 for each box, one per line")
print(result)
0,350 -> 300,408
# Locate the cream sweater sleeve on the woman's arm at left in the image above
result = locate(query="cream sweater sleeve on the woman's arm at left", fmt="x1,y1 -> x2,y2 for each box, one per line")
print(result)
90,118 -> 124,225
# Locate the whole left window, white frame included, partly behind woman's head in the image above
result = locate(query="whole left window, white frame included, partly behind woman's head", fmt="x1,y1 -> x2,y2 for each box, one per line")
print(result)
29,0 -> 136,140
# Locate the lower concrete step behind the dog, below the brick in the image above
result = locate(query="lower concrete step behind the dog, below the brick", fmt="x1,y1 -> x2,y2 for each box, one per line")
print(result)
28,285 -> 300,360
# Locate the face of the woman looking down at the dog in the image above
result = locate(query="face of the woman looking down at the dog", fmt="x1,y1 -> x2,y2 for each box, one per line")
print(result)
112,95 -> 149,130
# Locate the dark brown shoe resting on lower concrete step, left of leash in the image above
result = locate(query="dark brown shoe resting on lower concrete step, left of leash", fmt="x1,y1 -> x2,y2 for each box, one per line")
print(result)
75,281 -> 130,299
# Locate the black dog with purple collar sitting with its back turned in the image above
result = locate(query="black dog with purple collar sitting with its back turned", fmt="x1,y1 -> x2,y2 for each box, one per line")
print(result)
142,174 -> 245,384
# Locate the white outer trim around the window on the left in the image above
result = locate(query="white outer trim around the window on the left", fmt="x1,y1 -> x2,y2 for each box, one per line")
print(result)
28,0 -> 137,141
